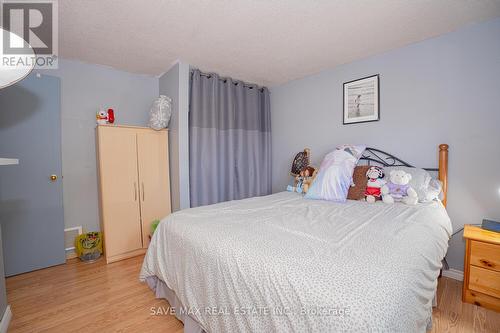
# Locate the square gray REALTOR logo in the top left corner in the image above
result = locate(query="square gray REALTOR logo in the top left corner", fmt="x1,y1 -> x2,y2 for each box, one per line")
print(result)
0,0 -> 58,69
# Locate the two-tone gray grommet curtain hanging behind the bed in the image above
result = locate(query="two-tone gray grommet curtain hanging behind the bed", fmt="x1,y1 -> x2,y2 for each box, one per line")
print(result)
189,70 -> 271,207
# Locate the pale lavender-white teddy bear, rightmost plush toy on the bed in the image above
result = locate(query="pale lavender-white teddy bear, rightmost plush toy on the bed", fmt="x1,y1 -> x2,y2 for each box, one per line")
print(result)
381,170 -> 418,205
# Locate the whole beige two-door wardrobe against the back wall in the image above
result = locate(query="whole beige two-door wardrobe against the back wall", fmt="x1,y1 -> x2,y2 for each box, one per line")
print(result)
97,125 -> 171,263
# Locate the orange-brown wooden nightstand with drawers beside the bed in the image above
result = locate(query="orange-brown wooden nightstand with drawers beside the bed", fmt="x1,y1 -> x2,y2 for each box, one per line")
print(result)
462,225 -> 500,311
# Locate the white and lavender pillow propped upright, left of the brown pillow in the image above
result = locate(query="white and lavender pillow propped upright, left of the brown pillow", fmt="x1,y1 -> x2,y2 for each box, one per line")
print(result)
305,145 -> 365,202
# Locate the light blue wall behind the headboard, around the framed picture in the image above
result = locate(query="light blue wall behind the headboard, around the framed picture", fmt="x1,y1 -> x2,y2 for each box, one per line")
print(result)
271,19 -> 500,270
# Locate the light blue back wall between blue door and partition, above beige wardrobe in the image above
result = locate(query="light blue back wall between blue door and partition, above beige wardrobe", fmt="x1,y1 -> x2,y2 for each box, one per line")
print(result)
41,60 -> 158,231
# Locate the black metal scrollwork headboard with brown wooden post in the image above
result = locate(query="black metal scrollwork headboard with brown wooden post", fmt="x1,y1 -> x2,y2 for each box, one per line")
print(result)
360,143 -> 449,207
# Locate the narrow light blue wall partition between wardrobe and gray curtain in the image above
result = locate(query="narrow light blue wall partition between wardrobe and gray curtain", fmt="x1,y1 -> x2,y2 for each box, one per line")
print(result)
159,62 -> 189,211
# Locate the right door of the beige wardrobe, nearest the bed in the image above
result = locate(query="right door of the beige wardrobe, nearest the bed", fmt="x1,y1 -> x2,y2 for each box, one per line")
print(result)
137,130 -> 170,248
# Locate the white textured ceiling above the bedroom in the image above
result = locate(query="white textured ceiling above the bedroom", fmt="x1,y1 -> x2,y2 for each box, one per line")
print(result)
59,0 -> 500,86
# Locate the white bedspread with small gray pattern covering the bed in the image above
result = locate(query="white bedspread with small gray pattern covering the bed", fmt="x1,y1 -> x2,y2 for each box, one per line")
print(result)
140,192 -> 451,332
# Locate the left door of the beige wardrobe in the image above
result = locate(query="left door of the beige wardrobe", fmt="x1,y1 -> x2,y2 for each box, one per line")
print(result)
97,126 -> 142,262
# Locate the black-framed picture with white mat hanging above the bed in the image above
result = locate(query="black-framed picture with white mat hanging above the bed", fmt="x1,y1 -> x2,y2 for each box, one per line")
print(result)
344,74 -> 380,125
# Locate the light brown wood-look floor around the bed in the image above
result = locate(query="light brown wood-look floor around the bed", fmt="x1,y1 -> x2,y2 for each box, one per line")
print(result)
7,256 -> 500,333
